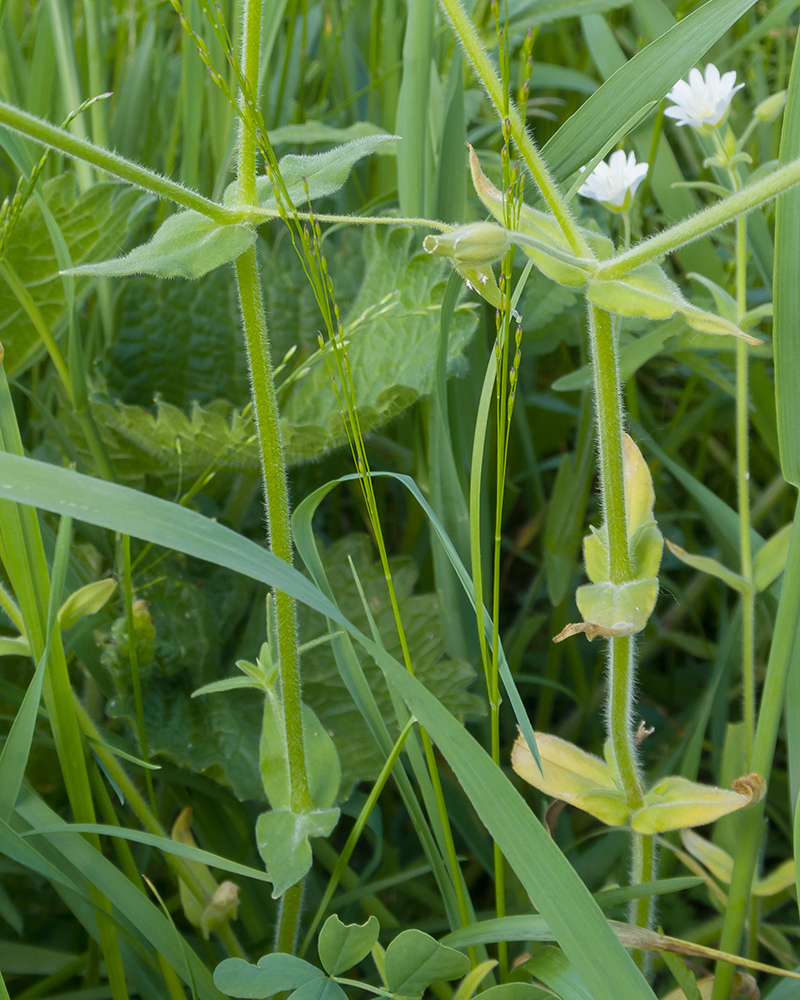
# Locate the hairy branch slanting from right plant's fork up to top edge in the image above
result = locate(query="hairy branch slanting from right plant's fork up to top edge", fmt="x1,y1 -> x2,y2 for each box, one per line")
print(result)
440,0 -> 594,259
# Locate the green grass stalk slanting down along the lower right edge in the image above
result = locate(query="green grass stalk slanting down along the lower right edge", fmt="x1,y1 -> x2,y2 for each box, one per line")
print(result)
712,494 -> 800,1000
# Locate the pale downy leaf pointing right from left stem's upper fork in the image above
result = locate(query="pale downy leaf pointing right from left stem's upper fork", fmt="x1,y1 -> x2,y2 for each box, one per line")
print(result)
222,132 -> 398,209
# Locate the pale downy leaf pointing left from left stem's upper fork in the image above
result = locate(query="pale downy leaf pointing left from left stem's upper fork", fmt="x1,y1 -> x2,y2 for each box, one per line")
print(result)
66,211 -> 256,280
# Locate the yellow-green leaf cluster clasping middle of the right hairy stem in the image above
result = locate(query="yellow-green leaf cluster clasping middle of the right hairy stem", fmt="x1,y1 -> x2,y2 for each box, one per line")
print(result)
555,434 -> 664,642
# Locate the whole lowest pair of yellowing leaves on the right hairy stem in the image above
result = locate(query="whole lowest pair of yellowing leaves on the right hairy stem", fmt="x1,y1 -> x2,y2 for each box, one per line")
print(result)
511,733 -> 766,834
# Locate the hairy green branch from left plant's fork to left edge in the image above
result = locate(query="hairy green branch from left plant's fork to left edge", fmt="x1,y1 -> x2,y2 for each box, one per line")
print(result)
0,101 -> 240,225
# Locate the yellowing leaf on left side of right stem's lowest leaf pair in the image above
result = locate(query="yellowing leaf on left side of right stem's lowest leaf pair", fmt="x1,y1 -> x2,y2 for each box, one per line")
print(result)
511,733 -> 629,826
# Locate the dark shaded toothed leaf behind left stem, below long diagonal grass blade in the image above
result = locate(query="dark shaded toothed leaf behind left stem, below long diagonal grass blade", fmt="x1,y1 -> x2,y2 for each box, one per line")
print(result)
102,535 -> 483,803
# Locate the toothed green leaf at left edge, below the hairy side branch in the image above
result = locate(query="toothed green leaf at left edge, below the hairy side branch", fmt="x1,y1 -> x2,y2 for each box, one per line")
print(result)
0,174 -> 142,375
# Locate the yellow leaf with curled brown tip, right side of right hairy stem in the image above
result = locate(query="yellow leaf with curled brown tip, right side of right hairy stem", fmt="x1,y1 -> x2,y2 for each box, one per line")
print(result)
631,774 -> 766,833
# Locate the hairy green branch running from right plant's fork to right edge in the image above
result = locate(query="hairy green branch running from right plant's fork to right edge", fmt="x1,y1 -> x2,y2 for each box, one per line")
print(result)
596,159 -> 800,280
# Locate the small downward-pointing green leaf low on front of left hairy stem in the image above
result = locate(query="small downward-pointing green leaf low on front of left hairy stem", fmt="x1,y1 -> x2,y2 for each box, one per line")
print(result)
256,809 -> 339,899
